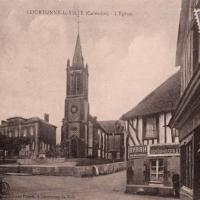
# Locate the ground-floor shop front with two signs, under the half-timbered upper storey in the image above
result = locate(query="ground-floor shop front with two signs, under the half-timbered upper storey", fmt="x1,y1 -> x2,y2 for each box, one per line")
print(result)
127,144 -> 180,196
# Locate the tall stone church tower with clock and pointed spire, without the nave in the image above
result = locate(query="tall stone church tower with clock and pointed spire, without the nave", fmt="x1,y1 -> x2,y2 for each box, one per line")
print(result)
61,33 -> 89,158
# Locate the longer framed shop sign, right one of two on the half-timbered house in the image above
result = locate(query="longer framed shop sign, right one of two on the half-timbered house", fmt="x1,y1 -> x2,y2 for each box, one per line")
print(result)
150,145 -> 180,154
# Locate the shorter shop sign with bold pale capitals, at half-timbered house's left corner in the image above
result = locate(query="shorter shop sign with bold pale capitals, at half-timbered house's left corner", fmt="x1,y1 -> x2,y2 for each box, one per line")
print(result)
128,145 -> 147,159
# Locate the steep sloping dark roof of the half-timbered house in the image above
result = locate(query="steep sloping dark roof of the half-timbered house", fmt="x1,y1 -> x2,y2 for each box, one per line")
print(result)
121,70 -> 181,120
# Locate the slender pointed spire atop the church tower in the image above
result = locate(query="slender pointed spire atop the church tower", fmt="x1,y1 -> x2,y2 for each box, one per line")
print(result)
72,34 -> 84,67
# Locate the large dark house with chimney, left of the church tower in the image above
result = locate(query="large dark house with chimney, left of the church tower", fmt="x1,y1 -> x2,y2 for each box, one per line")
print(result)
0,114 -> 56,158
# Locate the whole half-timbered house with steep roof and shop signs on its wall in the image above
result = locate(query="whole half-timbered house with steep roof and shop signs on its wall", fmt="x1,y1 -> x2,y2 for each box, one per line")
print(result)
122,71 -> 180,194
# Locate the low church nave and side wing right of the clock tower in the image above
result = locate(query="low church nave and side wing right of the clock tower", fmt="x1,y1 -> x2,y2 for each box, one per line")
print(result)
81,118 -> 125,161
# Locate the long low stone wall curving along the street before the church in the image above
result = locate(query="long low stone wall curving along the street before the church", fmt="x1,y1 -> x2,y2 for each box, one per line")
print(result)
0,162 -> 126,177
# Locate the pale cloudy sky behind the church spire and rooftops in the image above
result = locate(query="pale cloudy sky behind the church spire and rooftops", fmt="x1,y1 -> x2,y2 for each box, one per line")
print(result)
0,0 -> 181,143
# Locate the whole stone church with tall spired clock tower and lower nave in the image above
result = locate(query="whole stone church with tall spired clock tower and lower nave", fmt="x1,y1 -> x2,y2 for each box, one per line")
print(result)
61,33 -> 125,161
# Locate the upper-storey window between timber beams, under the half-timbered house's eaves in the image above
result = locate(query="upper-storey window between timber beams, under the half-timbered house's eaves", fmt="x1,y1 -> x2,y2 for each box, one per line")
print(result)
143,117 -> 158,139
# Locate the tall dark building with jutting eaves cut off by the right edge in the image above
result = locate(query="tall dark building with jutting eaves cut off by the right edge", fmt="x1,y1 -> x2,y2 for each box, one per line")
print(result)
170,0 -> 200,200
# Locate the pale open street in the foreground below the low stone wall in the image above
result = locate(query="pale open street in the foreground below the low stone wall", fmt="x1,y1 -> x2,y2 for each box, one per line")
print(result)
3,171 -> 178,200
